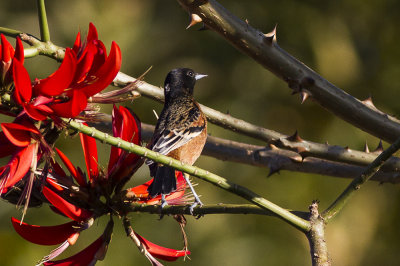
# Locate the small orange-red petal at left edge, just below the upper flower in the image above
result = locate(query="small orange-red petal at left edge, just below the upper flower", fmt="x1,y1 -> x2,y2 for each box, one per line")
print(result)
1,123 -> 40,147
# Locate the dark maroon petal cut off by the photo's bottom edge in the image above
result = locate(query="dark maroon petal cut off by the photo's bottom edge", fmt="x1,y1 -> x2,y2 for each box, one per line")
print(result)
43,235 -> 105,266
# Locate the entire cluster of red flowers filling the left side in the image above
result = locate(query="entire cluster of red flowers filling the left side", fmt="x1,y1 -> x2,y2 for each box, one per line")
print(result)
0,24 -> 189,265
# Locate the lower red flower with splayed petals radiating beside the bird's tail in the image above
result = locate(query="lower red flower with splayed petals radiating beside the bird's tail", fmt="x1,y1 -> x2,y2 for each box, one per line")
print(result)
9,106 -> 189,265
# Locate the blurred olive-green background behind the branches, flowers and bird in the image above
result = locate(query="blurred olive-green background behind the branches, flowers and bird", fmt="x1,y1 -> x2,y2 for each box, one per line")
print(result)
0,0 -> 400,265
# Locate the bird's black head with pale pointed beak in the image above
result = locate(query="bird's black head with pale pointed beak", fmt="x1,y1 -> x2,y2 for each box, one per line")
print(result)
164,68 -> 207,100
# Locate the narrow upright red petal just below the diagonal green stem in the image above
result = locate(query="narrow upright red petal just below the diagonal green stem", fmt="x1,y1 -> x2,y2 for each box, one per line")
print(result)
79,133 -> 99,180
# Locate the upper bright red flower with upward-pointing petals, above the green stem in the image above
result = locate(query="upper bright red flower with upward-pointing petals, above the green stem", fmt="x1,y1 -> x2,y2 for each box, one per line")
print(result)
12,23 -> 121,120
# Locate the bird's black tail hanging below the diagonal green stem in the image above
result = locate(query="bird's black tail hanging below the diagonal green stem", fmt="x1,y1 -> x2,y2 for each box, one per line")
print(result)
147,165 -> 176,198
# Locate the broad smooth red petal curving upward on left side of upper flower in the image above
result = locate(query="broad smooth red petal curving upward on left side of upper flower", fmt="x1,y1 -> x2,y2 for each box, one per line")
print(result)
33,48 -> 77,96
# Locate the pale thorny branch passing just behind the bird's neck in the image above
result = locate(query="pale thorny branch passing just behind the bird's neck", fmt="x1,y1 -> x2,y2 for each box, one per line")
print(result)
0,28 -> 400,178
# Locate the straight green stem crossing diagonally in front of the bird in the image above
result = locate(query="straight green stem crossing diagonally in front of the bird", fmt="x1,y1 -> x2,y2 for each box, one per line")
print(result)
63,118 -> 310,232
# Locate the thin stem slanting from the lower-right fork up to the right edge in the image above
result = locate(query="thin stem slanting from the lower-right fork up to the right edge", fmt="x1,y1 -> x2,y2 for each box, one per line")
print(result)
322,135 -> 400,223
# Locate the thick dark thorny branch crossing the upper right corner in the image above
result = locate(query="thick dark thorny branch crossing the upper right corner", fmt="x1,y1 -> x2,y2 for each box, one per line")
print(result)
177,0 -> 400,143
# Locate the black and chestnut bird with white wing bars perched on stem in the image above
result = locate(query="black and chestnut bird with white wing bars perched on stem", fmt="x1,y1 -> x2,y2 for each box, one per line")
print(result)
146,68 -> 207,213
